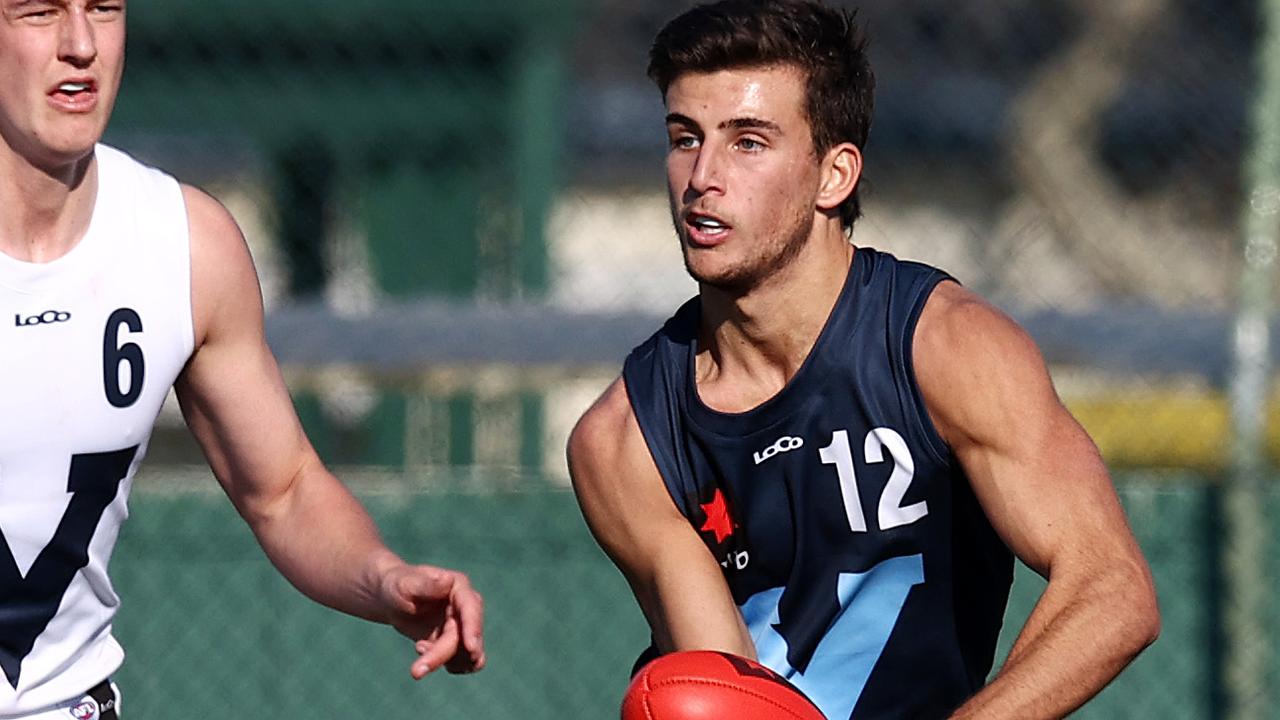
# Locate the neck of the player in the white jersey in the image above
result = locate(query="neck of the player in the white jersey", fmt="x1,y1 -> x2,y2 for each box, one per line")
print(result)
0,146 -> 97,263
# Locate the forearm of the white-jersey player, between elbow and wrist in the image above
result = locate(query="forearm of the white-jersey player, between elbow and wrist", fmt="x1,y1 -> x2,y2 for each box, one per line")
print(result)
241,462 -> 402,621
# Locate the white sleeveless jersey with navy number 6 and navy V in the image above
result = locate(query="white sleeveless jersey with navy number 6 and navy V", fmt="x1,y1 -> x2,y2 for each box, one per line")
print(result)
0,145 -> 195,717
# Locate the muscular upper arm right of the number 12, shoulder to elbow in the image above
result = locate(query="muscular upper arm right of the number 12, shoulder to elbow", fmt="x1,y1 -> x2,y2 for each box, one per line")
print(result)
914,283 -> 1138,575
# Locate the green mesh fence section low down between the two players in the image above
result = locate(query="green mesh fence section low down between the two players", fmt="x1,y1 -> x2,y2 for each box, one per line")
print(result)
113,480 -> 645,720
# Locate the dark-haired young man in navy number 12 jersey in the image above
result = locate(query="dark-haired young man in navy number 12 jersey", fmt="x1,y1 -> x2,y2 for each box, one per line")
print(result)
568,0 -> 1158,720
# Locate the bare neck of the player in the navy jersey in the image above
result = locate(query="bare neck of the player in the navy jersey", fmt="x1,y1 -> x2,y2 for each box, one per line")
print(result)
698,224 -> 854,411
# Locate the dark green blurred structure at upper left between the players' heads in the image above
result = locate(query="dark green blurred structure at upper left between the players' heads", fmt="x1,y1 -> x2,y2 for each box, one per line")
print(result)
109,0 -> 576,297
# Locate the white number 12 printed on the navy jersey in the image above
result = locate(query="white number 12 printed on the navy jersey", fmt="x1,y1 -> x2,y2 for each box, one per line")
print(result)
818,428 -> 929,533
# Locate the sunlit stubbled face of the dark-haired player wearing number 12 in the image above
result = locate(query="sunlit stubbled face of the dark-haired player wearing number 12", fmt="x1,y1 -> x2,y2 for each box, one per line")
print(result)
667,65 -> 820,291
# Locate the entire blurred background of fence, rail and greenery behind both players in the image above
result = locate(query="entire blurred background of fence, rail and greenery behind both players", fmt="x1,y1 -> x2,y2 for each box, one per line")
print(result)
108,0 -> 1280,720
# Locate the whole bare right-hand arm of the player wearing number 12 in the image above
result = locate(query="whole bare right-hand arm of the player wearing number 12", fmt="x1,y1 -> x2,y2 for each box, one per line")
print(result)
913,282 -> 1160,720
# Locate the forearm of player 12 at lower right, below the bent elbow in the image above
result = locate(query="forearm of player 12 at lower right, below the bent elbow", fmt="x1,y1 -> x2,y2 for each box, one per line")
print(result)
952,573 -> 1158,720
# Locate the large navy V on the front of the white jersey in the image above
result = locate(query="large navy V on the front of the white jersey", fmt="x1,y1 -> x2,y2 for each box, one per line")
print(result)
0,445 -> 138,689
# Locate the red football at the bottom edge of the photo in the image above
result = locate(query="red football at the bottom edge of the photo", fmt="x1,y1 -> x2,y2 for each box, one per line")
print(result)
622,650 -> 824,720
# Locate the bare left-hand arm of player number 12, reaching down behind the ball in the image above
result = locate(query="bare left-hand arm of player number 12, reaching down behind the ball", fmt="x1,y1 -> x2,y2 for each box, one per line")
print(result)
568,378 -> 755,659
